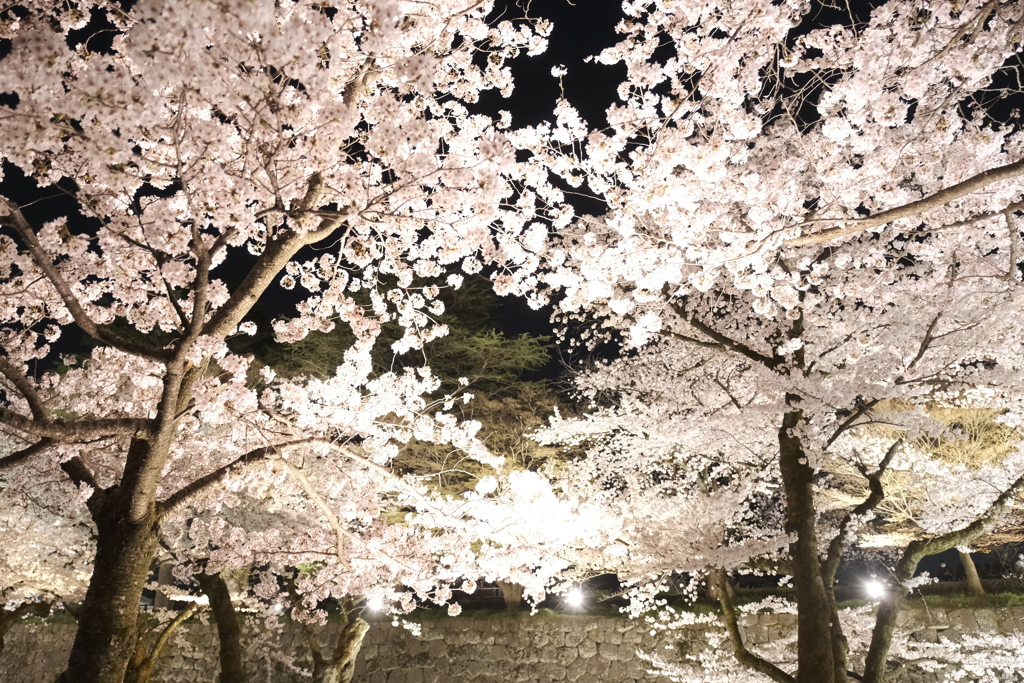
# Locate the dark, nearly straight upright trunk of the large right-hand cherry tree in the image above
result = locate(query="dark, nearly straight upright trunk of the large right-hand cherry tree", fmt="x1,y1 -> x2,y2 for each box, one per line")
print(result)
778,405 -> 836,683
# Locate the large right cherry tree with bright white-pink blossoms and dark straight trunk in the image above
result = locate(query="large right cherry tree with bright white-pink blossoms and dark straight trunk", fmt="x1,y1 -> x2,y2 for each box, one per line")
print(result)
520,0 -> 1024,682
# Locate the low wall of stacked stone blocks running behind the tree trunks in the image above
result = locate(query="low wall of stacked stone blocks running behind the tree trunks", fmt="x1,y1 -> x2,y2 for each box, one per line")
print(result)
0,607 -> 1024,683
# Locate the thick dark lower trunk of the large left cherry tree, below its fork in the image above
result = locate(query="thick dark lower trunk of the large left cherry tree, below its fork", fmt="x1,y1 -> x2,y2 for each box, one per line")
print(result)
57,490 -> 157,683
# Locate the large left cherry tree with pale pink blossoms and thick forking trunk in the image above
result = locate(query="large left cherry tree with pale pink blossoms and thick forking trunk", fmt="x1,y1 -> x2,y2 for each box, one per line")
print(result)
0,0 -> 547,683
